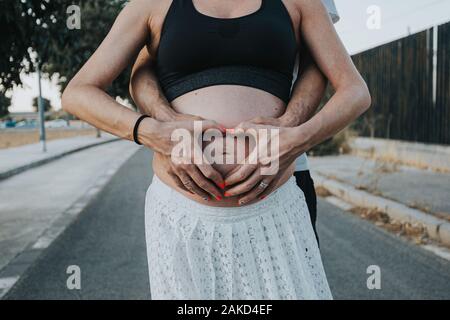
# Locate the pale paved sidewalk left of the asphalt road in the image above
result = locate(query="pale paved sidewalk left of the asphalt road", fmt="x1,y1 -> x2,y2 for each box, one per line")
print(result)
0,141 -> 138,270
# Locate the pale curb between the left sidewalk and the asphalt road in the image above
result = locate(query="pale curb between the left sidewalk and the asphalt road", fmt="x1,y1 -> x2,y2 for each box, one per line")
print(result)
0,144 -> 139,300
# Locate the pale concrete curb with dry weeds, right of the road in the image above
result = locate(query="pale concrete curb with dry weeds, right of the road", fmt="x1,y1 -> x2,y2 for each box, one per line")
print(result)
311,171 -> 450,245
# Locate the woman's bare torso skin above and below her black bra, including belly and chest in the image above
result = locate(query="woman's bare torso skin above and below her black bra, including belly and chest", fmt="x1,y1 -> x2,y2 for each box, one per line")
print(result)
149,0 -> 299,207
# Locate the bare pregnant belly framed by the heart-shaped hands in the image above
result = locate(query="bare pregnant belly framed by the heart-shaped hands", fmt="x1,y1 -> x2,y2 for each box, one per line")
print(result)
153,85 -> 294,207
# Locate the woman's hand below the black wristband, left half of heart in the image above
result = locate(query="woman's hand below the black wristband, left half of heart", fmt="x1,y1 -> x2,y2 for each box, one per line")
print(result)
138,118 -> 225,200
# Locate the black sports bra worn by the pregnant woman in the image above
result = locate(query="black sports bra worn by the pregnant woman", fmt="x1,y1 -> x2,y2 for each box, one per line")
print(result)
156,0 -> 298,103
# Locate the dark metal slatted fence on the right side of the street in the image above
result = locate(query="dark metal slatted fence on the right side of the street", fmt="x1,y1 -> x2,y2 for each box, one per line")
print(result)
352,23 -> 450,144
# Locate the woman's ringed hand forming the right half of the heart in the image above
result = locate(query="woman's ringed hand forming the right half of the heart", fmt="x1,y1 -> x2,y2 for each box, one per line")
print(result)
225,122 -> 304,205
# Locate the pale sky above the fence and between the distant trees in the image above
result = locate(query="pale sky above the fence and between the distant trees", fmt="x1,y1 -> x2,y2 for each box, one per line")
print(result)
9,0 -> 450,112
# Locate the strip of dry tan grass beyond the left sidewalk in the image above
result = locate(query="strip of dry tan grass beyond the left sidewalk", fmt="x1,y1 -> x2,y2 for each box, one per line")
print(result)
0,128 -> 96,149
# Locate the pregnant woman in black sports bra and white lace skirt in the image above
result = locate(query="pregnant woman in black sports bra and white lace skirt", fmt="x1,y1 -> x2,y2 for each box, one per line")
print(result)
62,0 -> 370,299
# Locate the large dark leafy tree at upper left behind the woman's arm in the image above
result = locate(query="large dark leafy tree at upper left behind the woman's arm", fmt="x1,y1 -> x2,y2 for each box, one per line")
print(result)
0,0 -> 130,98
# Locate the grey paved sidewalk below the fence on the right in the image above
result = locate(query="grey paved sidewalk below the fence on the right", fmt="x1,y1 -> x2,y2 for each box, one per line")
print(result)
309,155 -> 450,220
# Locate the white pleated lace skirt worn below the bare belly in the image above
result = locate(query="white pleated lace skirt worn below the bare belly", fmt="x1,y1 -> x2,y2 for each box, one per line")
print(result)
145,176 -> 332,299
